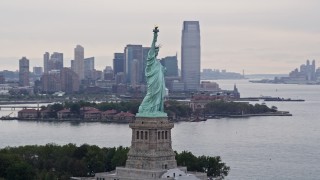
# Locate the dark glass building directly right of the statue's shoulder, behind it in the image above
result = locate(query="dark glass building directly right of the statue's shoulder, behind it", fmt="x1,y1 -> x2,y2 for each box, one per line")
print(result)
160,55 -> 178,77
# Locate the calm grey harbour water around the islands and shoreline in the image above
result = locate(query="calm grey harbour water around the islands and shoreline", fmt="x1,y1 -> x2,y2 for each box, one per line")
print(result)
0,80 -> 320,180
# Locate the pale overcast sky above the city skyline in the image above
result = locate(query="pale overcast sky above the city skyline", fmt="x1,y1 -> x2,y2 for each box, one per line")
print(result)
0,0 -> 320,74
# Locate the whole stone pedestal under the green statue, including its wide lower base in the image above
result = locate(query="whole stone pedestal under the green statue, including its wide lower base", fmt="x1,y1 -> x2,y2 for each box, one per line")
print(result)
95,117 -> 207,180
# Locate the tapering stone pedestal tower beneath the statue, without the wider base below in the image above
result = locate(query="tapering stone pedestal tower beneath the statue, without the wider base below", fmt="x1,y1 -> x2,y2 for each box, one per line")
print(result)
126,117 -> 177,170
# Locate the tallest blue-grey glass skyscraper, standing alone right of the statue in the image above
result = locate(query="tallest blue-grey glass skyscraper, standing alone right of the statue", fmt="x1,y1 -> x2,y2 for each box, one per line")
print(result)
181,21 -> 201,91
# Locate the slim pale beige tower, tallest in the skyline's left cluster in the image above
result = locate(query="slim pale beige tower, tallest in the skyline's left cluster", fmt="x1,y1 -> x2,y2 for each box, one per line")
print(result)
74,45 -> 84,80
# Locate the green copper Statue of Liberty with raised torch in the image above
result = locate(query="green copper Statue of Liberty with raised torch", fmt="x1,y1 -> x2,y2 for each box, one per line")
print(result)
136,26 -> 167,117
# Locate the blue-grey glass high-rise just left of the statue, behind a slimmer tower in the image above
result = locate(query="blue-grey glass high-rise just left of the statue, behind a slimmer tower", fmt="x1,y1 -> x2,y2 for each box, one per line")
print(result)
124,44 -> 143,84
